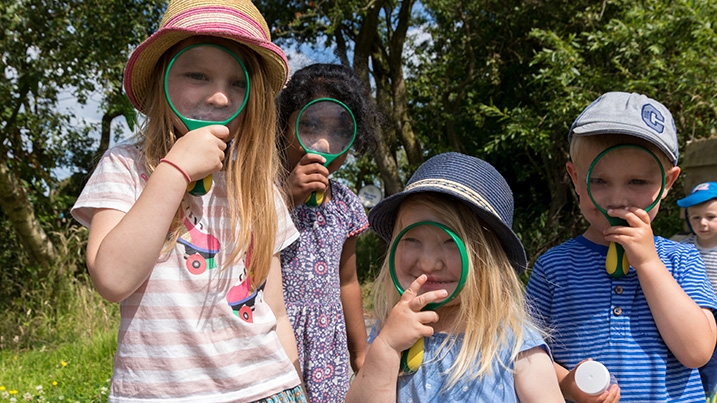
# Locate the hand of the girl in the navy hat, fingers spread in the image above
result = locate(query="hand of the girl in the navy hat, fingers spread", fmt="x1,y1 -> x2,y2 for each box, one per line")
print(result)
376,274 -> 448,354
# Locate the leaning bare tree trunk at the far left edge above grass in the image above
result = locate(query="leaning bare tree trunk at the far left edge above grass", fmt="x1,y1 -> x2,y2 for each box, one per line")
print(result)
0,157 -> 57,269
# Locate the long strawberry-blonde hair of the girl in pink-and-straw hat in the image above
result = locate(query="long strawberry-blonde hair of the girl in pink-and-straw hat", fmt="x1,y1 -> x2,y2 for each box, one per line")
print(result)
139,45 -> 279,285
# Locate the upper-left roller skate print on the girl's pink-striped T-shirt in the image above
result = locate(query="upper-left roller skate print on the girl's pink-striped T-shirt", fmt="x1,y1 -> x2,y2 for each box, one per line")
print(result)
177,208 -> 221,275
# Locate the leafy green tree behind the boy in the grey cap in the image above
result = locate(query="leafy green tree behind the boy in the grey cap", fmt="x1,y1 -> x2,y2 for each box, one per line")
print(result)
410,0 -> 717,258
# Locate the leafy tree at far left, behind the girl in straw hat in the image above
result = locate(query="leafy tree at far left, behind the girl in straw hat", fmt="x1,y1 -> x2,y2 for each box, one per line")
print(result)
0,0 -> 165,274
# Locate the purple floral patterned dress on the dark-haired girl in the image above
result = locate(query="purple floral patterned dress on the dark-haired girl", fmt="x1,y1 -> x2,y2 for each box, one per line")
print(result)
281,181 -> 368,403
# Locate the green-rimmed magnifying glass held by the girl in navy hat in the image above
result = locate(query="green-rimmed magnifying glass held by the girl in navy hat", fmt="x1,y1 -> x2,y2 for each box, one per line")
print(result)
388,221 -> 468,374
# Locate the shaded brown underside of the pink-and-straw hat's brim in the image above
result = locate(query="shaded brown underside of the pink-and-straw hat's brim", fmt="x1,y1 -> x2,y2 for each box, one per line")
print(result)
124,27 -> 289,113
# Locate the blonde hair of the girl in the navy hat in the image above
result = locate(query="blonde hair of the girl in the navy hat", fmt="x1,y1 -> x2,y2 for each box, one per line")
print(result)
374,193 -> 538,388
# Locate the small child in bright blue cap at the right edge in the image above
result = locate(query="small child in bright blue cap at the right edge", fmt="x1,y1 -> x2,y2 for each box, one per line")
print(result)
677,182 -> 717,402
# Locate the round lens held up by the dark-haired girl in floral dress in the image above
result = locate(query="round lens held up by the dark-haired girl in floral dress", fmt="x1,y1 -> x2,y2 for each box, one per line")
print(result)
297,101 -> 354,154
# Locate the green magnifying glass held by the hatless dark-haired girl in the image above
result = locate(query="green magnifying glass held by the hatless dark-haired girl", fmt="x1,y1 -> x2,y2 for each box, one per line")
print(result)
296,98 -> 356,207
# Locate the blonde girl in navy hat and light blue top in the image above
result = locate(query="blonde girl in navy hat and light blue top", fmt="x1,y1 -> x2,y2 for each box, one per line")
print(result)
347,153 -> 563,402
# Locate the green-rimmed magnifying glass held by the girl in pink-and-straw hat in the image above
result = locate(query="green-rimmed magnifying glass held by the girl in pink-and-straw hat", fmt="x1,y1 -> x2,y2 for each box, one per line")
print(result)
164,43 -> 249,196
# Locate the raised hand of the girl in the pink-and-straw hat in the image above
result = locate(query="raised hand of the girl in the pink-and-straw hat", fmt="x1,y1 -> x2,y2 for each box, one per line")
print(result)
165,125 -> 229,181
